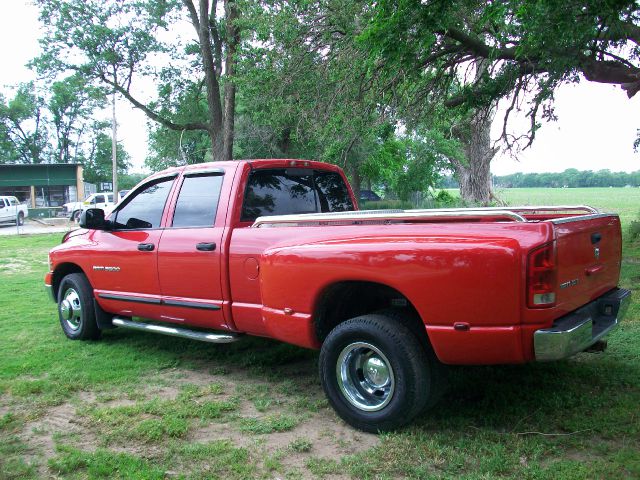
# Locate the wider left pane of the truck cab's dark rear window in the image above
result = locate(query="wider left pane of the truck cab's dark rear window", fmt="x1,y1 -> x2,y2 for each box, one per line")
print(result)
241,168 -> 318,221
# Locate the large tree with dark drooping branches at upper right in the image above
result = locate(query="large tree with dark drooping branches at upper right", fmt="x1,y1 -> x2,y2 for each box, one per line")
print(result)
362,0 -> 640,201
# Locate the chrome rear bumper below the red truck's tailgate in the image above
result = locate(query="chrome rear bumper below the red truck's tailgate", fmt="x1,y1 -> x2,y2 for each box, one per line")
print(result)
533,288 -> 631,362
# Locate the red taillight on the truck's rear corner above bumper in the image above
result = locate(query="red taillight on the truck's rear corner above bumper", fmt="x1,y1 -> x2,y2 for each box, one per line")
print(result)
527,242 -> 557,308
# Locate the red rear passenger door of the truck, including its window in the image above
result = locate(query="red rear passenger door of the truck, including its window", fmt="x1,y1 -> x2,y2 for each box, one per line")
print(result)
158,169 -> 226,328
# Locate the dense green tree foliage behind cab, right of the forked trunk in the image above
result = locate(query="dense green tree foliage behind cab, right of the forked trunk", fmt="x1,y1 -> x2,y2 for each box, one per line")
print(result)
236,0 -> 448,196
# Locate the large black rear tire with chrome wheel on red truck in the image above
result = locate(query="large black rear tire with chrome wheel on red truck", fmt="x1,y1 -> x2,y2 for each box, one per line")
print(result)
320,313 -> 439,432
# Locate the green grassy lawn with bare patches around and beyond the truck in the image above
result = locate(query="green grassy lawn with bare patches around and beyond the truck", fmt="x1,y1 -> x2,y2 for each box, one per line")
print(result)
0,189 -> 640,479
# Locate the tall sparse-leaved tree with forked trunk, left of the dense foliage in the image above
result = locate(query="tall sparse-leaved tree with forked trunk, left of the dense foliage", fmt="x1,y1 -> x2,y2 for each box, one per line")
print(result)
34,0 -> 240,160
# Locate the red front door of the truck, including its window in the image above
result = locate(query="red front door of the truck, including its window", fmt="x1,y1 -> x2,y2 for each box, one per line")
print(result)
89,175 -> 176,319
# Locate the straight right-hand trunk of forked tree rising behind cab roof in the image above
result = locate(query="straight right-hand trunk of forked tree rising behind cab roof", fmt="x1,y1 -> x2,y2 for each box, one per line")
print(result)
223,0 -> 240,160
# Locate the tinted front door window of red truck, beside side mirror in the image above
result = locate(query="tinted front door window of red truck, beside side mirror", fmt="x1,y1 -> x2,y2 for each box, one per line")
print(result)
113,178 -> 173,230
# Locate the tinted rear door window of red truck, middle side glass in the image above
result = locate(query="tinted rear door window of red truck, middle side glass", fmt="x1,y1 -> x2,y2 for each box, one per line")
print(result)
172,175 -> 224,227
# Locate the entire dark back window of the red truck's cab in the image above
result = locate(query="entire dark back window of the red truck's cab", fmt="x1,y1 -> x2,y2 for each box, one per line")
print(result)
241,168 -> 353,221
